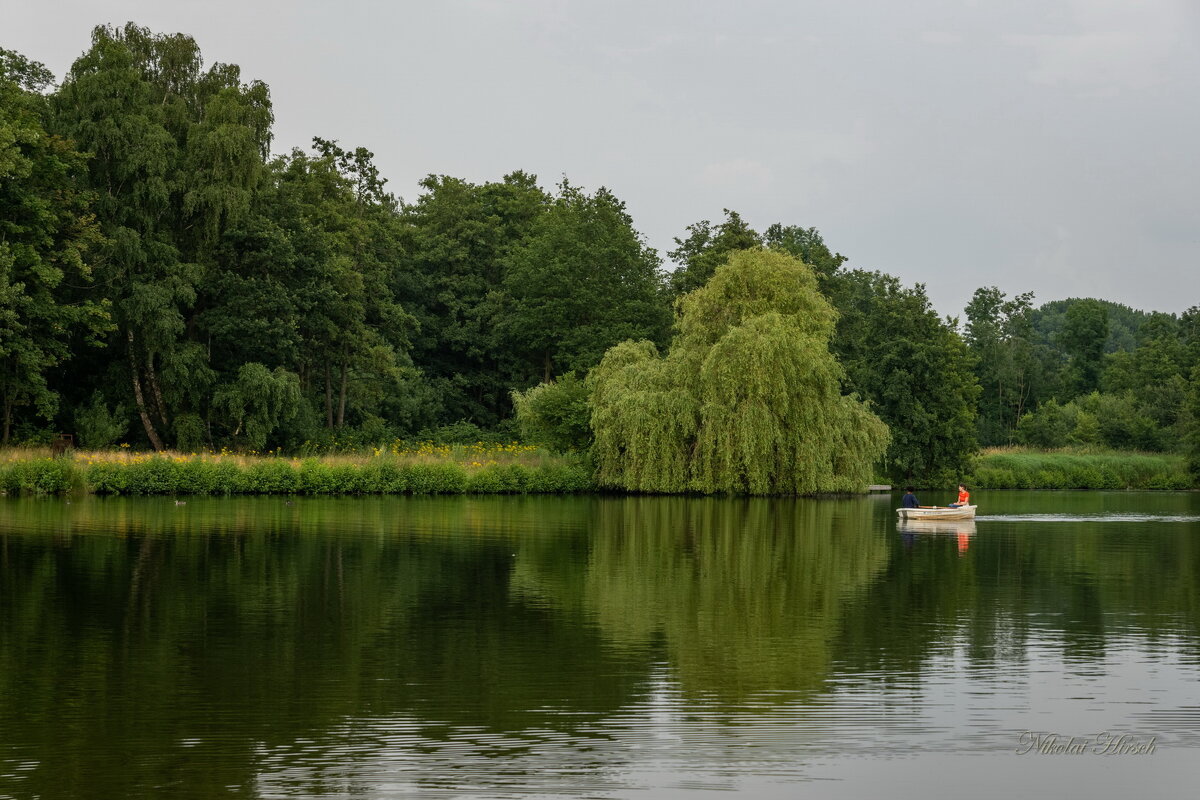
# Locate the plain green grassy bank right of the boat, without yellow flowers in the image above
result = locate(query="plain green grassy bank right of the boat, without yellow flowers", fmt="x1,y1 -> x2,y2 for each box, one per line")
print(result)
967,447 -> 1195,489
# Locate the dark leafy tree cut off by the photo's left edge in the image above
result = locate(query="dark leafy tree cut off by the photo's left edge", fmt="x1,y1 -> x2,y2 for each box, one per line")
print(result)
0,49 -> 109,445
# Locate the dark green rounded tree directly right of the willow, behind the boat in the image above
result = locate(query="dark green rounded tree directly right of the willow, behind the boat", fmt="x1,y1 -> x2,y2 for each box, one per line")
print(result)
829,270 -> 979,485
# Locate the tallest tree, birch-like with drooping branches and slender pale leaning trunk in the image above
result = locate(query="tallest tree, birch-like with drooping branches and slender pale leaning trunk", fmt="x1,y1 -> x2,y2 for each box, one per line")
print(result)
55,24 -> 272,449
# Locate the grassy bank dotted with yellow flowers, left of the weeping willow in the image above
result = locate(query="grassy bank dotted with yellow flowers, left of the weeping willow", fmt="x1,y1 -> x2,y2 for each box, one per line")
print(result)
0,444 -> 595,495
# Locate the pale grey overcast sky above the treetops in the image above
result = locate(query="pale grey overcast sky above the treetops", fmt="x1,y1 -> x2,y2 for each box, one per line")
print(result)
9,0 -> 1200,314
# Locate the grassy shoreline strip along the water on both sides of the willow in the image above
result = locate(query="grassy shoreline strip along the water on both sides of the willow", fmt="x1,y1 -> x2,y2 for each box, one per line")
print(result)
0,444 -> 1200,497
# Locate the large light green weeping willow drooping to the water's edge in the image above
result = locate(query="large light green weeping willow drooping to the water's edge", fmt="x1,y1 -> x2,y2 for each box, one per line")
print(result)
589,249 -> 888,494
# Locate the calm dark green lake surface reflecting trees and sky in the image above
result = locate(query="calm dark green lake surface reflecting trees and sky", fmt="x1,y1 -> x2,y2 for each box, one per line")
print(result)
0,492 -> 1200,800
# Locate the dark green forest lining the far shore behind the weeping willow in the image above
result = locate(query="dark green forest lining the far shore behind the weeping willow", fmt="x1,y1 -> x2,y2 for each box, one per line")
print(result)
0,24 -> 1200,480
